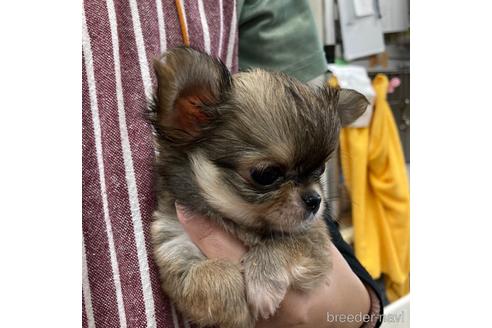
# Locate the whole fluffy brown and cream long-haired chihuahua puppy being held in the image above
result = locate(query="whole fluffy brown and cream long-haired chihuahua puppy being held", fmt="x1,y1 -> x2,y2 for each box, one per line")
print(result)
150,47 -> 368,328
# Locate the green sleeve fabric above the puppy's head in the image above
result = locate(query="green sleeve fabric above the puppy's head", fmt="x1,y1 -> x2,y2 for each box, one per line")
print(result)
237,0 -> 327,82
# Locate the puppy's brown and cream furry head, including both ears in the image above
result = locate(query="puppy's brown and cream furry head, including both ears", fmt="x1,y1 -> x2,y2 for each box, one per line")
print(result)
153,48 -> 368,232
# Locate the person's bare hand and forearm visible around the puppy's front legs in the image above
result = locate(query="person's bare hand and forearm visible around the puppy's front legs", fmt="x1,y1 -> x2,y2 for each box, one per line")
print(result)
177,207 -> 380,328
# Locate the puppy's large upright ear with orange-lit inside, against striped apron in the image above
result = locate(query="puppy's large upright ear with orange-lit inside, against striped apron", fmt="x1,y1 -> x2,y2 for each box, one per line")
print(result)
154,47 -> 232,143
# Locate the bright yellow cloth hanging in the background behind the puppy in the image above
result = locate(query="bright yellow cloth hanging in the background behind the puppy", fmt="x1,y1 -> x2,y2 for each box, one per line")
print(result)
338,74 -> 410,301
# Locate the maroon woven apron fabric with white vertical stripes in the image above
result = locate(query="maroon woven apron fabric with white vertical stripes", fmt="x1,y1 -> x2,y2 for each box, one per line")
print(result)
82,0 -> 237,328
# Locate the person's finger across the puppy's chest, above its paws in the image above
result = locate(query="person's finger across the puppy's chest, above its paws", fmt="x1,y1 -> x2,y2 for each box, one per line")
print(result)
176,204 -> 247,263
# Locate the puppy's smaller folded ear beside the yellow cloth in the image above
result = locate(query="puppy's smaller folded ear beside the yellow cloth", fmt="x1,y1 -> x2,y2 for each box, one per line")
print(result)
337,89 -> 369,126
